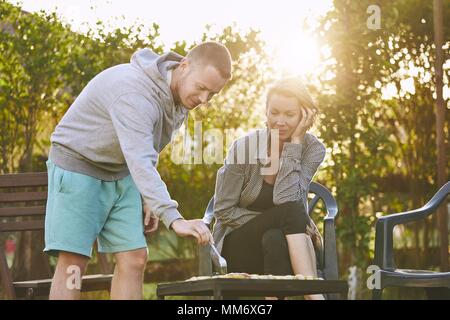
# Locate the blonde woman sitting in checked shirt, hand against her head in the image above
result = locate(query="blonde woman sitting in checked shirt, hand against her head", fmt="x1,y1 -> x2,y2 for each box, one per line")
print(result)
213,78 -> 325,299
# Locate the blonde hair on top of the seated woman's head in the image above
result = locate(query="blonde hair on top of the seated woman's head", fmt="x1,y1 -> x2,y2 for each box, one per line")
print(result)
266,77 -> 318,111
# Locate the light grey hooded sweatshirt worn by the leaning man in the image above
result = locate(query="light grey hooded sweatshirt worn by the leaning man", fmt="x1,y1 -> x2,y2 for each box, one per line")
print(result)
49,49 -> 188,228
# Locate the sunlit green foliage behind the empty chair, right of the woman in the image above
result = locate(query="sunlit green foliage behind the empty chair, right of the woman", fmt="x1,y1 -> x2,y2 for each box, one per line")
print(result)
317,0 -> 450,276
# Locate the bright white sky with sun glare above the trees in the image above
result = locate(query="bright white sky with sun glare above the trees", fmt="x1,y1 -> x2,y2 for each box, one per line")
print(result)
9,0 -> 332,75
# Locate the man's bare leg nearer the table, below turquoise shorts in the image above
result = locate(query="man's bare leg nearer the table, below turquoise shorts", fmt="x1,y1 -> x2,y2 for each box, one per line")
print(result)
111,248 -> 147,300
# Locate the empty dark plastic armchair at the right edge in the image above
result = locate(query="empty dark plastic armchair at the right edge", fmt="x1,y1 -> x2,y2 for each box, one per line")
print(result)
372,181 -> 450,300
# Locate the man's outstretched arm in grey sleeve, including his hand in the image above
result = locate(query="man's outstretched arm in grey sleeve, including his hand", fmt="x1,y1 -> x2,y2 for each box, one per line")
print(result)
109,93 -> 212,243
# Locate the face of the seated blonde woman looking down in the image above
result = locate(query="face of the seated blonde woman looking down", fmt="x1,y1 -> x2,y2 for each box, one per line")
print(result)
266,93 -> 302,141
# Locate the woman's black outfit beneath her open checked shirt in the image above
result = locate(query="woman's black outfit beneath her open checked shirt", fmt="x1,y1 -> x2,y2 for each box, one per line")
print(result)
222,181 -> 308,275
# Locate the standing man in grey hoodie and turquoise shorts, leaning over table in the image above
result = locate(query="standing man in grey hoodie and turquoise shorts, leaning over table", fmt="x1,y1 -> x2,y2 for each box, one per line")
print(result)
44,42 -> 231,299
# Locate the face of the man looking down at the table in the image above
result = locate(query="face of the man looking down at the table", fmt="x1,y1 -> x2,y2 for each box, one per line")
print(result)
177,60 -> 227,110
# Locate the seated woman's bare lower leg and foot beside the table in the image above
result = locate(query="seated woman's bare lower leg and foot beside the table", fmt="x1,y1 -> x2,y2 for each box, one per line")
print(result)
286,233 -> 325,300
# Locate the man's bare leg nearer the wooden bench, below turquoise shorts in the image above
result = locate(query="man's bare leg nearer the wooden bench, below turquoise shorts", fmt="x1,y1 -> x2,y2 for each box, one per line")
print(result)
49,251 -> 89,300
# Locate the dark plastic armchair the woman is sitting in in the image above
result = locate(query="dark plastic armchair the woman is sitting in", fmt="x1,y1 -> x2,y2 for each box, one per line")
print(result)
199,182 -> 339,299
